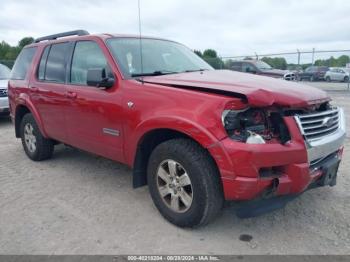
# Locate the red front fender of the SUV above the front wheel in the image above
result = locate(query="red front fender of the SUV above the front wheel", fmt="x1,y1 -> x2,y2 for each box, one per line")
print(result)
123,80 -> 238,166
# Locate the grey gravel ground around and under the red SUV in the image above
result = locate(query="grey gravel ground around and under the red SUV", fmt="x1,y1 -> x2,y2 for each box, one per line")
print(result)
0,83 -> 350,254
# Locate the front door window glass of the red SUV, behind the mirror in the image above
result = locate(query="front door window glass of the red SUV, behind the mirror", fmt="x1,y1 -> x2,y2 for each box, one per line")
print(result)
70,41 -> 108,85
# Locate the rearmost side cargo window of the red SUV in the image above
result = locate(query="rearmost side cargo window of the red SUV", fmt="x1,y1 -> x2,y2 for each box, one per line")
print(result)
11,47 -> 36,80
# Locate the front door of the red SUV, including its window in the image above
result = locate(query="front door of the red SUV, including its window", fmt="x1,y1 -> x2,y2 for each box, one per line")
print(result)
67,40 -> 123,161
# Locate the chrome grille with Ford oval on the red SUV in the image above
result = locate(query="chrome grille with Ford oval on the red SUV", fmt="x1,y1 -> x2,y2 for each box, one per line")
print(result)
298,108 -> 339,141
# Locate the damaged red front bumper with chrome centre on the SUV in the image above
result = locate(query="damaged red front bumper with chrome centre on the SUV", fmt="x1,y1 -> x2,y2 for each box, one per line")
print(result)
212,110 -> 345,200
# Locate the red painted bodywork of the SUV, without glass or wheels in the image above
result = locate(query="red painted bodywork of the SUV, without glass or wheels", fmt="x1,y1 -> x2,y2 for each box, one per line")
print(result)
9,35 -> 338,200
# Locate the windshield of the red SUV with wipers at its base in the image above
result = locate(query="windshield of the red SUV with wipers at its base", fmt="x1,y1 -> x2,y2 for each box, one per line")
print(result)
107,38 -> 213,76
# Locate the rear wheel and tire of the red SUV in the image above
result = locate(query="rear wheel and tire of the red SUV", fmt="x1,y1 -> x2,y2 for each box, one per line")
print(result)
20,114 -> 54,161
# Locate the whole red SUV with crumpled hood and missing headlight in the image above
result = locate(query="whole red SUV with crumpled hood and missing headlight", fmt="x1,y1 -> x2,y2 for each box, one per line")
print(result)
9,30 -> 345,227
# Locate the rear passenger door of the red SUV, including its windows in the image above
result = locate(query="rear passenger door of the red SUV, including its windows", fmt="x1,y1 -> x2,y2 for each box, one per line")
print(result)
30,42 -> 71,142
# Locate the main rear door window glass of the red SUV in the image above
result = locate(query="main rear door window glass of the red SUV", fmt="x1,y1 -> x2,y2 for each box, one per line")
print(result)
45,43 -> 68,83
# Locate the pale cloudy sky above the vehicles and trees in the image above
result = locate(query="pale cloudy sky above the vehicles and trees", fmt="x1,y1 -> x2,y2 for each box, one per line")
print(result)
0,0 -> 350,60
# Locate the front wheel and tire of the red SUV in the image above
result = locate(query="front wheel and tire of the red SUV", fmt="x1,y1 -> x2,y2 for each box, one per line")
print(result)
147,139 -> 224,227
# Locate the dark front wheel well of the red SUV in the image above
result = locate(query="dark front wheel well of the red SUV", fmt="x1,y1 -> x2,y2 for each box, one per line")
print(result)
133,129 -> 216,188
